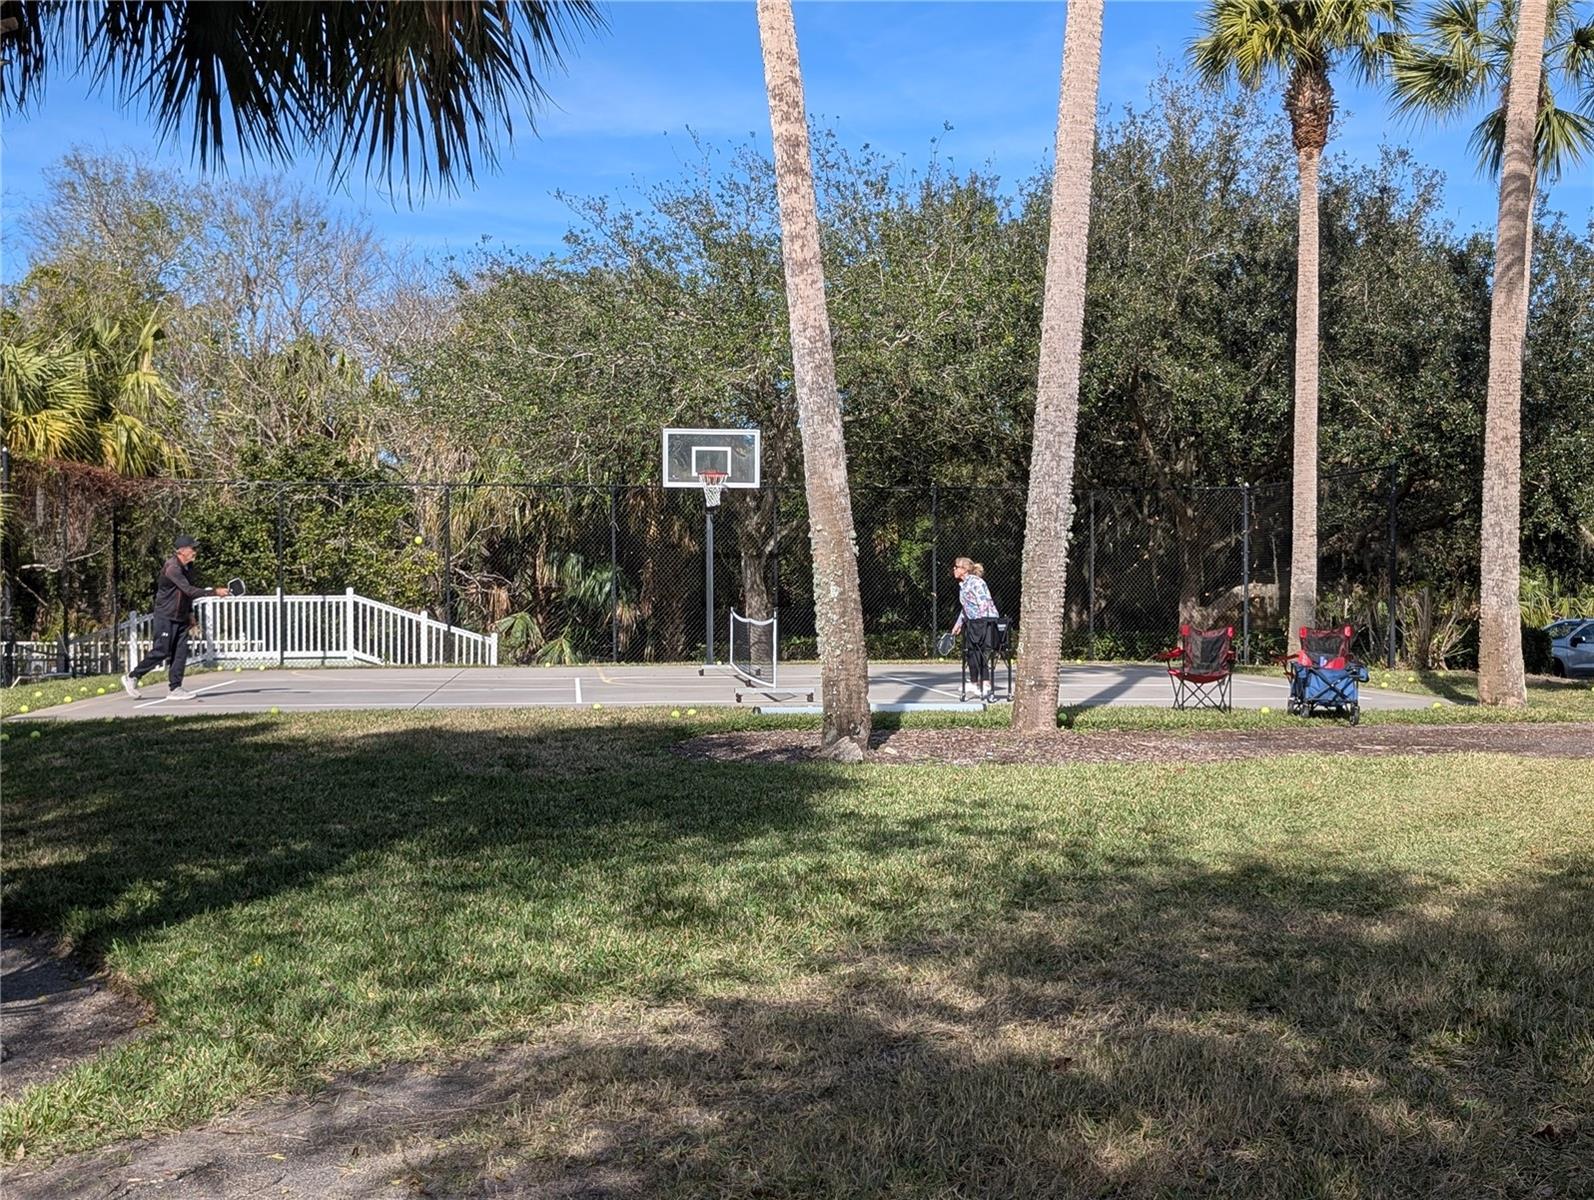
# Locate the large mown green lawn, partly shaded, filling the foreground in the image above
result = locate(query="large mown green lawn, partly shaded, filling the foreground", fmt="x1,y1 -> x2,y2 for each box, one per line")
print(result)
0,711 -> 1594,1197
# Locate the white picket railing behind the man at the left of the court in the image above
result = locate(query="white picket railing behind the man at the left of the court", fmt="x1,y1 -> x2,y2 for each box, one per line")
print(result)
13,588 -> 497,677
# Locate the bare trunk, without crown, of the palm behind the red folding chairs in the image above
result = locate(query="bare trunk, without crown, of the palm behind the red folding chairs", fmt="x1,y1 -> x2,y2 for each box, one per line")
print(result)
1288,145 -> 1323,653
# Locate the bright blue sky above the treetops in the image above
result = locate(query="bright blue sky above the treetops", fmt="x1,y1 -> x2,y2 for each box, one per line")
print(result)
0,0 -> 1594,280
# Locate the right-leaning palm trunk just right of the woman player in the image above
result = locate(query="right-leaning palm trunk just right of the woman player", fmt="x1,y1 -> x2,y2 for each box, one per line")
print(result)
1012,0 -> 1103,733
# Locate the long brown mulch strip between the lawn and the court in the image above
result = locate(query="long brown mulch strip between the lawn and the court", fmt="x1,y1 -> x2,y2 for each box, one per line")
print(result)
676,724 -> 1594,767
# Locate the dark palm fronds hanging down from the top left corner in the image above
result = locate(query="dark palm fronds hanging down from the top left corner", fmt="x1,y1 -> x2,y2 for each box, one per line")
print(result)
0,0 -> 603,190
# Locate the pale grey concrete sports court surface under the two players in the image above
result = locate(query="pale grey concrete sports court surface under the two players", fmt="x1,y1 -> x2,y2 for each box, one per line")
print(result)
21,663 -> 1433,720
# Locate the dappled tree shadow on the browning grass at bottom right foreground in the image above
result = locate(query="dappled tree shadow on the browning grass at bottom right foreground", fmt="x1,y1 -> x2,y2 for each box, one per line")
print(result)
13,861 -> 1594,1200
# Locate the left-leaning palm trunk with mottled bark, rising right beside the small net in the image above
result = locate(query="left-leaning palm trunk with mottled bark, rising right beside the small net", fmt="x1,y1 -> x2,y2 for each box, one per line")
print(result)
759,0 -> 869,760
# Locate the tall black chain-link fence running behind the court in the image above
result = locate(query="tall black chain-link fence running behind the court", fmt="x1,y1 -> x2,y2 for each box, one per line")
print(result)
3,465 -> 1427,680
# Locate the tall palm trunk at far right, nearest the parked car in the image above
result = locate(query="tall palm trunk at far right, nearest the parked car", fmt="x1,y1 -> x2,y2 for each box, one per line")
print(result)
1478,0 -> 1546,708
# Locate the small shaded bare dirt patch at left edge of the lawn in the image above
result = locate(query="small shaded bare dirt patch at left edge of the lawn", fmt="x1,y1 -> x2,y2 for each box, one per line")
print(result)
0,929 -> 145,1096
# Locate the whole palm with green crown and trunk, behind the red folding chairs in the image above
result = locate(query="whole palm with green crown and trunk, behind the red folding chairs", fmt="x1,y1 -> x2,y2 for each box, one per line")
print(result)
1191,0 -> 1406,650
